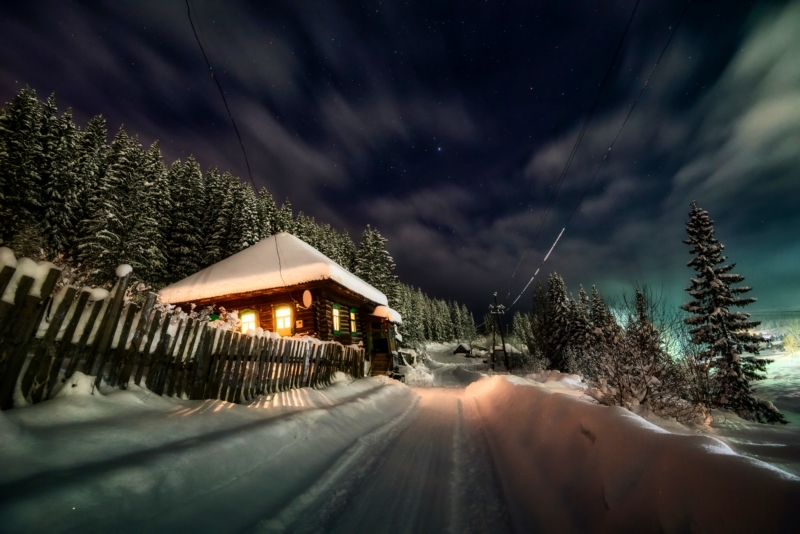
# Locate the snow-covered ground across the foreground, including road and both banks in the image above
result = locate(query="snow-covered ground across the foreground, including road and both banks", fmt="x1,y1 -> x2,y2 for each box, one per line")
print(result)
0,363 -> 800,533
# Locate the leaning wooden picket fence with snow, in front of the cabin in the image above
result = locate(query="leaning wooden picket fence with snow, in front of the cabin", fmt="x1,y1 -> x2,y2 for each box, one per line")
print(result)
0,249 -> 364,410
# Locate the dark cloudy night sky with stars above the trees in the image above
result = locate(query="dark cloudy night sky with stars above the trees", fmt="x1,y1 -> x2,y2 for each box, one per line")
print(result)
0,0 -> 800,314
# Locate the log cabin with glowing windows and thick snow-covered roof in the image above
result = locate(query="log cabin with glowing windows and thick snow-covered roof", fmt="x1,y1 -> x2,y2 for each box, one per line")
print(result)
159,233 -> 402,374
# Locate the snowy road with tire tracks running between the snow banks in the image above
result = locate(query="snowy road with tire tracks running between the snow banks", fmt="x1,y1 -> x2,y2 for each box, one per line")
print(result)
288,389 -> 510,534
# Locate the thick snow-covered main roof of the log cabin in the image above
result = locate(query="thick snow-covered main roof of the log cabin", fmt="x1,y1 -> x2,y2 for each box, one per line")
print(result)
158,232 -> 388,305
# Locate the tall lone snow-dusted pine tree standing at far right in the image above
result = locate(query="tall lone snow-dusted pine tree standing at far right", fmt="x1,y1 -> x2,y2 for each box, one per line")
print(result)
683,202 -> 786,423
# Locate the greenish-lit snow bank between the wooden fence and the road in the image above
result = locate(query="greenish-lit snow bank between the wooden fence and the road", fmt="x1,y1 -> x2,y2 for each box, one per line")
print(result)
0,373 -> 417,532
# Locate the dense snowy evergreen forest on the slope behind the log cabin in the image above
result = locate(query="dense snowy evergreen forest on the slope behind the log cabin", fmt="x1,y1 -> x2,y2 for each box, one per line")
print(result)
0,87 -> 475,344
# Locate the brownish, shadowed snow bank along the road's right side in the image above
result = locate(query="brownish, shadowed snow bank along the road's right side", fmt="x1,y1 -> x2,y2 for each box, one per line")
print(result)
466,376 -> 800,532
